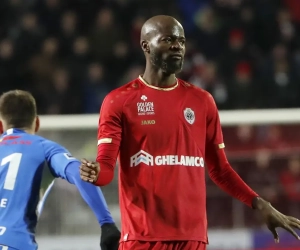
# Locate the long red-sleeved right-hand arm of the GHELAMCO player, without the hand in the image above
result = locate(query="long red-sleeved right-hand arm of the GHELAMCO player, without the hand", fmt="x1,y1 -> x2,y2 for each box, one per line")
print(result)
205,93 -> 258,207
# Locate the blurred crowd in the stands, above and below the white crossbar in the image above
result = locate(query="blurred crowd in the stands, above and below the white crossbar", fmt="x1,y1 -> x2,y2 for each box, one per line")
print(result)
0,0 -> 300,231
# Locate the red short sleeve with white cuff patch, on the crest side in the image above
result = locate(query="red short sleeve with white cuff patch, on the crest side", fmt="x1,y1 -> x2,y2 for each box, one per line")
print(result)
206,94 -> 225,148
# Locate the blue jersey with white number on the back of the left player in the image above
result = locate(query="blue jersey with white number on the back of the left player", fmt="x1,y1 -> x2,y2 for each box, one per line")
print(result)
0,129 -> 112,250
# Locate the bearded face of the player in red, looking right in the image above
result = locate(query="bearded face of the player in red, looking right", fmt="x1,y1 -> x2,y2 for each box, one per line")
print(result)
150,25 -> 185,74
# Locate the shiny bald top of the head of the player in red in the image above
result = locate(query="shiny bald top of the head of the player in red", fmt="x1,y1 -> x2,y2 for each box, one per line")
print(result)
141,15 -> 183,42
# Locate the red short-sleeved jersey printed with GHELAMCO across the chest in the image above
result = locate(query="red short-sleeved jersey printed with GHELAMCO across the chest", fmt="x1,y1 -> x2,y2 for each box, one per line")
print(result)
98,77 -> 255,243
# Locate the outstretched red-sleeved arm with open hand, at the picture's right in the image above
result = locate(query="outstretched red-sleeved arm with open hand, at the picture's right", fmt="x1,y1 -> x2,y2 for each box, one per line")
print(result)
205,93 -> 300,242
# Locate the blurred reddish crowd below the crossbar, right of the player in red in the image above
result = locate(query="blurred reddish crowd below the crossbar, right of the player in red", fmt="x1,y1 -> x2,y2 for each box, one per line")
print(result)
207,125 -> 300,227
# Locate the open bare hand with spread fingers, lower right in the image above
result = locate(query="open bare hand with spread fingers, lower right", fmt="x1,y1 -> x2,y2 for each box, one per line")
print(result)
253,197 -> 300,243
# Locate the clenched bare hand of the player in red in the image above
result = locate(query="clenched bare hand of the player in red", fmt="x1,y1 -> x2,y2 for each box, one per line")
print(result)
80,159 -> 100,183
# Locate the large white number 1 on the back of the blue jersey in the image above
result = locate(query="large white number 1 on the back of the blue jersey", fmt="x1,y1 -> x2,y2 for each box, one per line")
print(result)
1,153 -> 22,190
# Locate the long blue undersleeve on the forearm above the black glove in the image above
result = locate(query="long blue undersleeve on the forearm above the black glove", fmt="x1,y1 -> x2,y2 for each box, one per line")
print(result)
65,162 -> 114,226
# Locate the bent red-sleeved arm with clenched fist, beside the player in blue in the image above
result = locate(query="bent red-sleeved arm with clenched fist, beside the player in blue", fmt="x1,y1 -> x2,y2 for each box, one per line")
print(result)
80,94 -> 122,186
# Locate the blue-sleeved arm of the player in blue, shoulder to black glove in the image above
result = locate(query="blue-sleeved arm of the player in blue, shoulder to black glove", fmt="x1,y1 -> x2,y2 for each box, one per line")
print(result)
42,141 -> 114,226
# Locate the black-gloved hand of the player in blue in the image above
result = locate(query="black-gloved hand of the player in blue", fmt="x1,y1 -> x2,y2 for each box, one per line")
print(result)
100,223 -> 121,250
